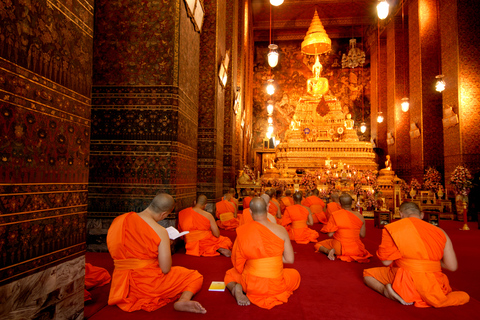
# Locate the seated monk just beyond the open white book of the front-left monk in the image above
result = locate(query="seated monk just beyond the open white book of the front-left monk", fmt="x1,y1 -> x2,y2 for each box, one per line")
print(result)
178,195 -> 232,257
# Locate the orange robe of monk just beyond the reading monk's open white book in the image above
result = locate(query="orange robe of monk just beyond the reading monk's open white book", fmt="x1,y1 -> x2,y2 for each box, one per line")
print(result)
178,208 -> 232,257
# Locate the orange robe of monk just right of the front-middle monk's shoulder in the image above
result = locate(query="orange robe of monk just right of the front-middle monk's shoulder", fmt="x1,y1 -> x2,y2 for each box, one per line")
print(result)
281,204 -> 318,244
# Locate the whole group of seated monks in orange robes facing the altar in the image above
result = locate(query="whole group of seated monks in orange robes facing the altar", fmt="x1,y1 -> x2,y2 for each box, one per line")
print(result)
86,189 -> 469,313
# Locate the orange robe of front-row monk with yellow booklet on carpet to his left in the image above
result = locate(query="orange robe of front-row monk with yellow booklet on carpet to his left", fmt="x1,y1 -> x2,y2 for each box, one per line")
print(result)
224,221 -> 300,309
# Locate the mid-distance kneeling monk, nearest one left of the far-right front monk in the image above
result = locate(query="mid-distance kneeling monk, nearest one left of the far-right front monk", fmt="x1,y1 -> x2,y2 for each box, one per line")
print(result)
315,193 -> 372,263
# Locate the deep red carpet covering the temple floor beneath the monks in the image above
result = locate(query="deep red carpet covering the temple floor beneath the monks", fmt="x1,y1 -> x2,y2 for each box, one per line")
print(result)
85,220 -> 480,320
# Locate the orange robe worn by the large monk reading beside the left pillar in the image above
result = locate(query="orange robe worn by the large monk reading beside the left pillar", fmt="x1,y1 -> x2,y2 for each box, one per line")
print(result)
107,212 -> 203,312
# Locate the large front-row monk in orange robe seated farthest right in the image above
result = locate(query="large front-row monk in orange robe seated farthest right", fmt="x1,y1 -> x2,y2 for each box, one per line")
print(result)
363,202 -> 470,308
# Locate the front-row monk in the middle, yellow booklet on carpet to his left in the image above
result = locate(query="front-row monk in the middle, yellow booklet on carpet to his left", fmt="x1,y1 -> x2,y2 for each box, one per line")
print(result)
225,198 -> 300,309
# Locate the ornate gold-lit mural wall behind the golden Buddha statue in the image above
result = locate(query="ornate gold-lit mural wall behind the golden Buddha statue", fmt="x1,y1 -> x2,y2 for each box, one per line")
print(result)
253,39 -> 370,148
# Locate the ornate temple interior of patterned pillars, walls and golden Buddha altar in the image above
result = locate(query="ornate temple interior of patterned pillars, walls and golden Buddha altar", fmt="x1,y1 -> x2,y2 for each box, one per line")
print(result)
0,0 -> 480,319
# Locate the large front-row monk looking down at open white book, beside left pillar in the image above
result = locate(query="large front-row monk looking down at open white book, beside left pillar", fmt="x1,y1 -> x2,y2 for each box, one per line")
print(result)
107,193 -> 206,313
